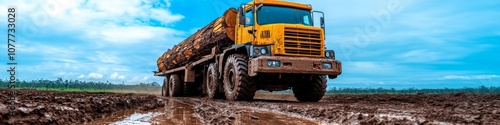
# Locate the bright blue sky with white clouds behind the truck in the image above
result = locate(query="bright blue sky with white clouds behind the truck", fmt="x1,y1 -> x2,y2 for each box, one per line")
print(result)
0,0 -> 500,88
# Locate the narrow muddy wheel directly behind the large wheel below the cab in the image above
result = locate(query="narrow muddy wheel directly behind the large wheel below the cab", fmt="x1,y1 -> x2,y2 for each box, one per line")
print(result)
203,63 -> 224,99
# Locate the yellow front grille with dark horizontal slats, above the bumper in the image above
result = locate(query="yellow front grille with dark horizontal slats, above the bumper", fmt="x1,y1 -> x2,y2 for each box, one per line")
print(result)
285,27 -> 323,57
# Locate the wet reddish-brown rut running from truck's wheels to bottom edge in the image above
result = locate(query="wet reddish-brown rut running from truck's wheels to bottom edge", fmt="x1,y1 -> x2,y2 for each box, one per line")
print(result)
170,98 -> 319,125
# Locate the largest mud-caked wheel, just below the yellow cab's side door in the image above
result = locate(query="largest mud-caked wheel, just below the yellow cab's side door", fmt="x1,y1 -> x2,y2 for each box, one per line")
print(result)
223,54 -> 257,101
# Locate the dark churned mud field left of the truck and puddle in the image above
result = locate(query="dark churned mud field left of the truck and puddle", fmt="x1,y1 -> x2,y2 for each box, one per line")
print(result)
0,89 -> 165,124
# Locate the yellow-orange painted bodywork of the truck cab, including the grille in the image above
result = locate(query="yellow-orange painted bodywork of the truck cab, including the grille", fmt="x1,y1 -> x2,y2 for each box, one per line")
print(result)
235,0 -> 325,57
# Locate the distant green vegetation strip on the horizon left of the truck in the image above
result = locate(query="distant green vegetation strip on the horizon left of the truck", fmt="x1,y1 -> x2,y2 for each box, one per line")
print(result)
0,78 -> 161,92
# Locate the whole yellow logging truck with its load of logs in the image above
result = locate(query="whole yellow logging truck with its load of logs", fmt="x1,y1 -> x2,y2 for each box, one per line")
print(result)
153,0 -> 342,102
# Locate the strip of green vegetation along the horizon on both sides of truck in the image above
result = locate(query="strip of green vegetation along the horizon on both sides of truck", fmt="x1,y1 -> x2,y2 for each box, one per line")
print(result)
0,78 -> 500,94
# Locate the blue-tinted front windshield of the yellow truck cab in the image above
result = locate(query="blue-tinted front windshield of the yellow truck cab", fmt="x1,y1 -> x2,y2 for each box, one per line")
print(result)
257,6 -> 312,26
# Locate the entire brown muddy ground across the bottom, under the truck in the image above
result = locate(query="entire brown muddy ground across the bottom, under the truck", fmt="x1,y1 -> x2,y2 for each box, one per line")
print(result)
0,89 -> 500,124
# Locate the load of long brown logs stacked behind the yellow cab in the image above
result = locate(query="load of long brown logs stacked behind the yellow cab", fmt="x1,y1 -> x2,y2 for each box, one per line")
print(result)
157,8 -> 237,72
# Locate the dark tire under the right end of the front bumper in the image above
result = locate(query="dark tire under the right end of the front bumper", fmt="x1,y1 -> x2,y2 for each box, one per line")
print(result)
292,76 -> 326,102
